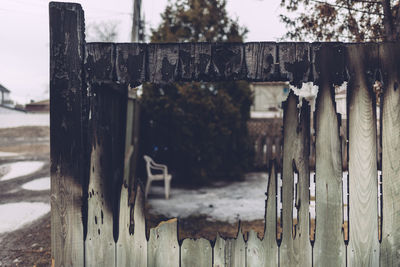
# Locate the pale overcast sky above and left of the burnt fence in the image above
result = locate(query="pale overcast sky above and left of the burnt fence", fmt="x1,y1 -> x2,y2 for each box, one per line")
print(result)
0,0 -> 285,104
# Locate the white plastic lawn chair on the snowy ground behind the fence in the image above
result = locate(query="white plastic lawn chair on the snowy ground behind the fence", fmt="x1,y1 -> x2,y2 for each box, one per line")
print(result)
143,155 -> 172,199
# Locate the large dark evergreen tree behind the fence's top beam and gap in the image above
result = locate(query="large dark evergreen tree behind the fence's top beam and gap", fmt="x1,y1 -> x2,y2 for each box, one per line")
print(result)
141,0 -> 252,184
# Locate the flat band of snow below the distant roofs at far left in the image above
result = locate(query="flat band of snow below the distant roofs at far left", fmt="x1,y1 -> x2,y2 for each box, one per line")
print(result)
0,113 -> 50,128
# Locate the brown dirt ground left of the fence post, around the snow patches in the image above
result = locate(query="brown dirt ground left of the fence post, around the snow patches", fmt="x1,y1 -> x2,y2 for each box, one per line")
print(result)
0,126 -> 51,267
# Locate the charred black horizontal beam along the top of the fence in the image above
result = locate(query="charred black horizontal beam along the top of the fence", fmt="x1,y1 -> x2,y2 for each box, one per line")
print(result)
85,42 -> 384,87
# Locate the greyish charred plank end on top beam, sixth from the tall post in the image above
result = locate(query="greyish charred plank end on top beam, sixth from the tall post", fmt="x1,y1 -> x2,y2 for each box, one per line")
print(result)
244,43 -> 278,81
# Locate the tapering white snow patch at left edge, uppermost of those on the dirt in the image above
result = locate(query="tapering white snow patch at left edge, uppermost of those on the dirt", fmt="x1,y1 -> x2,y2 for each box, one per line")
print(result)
0,161 -> 44,181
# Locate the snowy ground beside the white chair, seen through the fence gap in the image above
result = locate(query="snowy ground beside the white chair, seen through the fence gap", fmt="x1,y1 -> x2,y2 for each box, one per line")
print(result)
148,173 -> 268,223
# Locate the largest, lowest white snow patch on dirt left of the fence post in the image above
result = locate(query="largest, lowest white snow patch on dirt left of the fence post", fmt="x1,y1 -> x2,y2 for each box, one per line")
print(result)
0,202 -> 50,234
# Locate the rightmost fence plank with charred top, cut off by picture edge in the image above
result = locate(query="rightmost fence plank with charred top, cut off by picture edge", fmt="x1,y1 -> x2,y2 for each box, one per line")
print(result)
379,44 -> 400,267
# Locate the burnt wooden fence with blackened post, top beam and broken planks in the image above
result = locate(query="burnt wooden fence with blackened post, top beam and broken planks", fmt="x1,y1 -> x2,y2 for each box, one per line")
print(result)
50,3 -> 400,267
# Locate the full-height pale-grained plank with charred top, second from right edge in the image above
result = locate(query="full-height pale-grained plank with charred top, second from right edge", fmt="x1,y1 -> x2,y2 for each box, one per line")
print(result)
346,44 -> 379,266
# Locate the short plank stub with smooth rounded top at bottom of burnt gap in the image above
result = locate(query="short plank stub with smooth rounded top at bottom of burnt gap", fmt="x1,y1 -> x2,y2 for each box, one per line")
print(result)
180,238 -> 212,267
